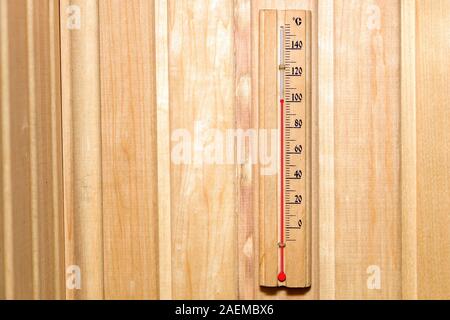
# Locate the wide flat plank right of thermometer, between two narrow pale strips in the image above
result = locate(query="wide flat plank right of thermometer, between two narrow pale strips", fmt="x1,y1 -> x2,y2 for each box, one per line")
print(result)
334,1 -> 401,299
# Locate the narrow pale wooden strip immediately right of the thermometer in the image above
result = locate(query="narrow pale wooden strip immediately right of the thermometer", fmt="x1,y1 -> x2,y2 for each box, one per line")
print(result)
317,0 -> 336,300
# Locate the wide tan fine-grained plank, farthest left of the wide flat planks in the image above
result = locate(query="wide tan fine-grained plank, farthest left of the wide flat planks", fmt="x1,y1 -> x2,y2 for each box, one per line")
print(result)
100,0 -> 159,299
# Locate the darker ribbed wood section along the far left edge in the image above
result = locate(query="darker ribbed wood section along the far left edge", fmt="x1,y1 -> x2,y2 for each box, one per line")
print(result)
1,0 -> 64,299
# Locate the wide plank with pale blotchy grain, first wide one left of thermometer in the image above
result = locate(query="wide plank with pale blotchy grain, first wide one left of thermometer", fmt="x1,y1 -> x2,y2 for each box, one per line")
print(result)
169,0 -> 238,299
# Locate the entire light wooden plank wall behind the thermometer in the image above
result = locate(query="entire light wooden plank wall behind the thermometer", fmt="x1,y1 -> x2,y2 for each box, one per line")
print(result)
0,0 -> 450,299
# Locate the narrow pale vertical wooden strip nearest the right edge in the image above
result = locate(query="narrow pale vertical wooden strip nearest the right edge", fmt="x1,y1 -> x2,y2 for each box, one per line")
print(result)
401,0 -> 418,299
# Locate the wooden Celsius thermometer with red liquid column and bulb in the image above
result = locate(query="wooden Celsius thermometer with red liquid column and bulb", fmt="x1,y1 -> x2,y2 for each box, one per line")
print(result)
259,10 -> 311,288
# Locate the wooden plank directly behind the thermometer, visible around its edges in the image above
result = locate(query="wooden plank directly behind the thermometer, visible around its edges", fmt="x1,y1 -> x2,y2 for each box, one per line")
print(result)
251,0 -> 319,299
